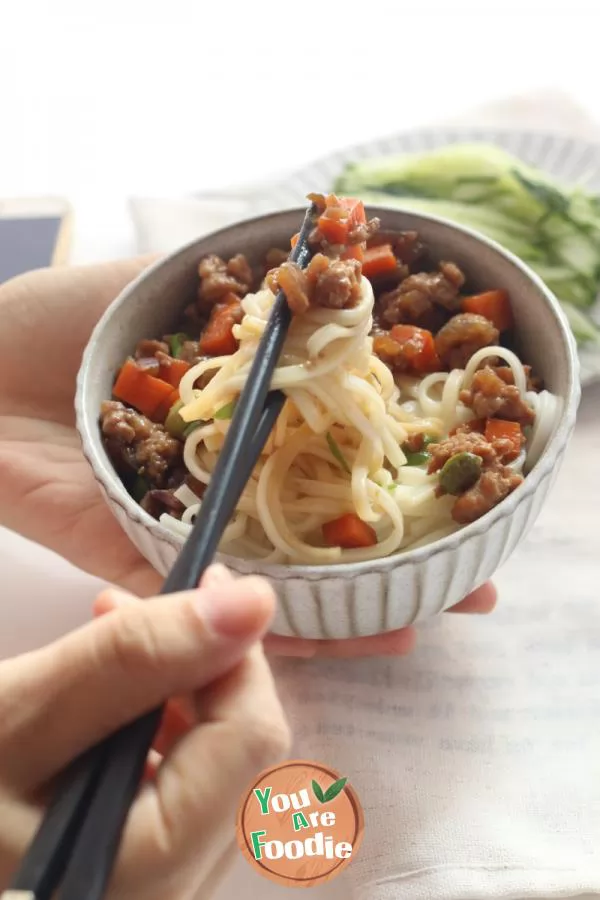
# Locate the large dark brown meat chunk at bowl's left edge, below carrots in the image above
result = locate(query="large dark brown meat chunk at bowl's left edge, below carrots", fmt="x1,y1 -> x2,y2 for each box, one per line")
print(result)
100,400 -> 183,488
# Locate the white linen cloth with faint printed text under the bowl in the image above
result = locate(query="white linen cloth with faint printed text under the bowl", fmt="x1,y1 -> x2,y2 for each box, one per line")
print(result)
132,92 -> 600,900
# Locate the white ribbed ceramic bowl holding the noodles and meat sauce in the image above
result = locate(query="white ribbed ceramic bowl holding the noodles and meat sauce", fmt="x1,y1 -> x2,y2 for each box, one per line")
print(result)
76,207 -> 580,638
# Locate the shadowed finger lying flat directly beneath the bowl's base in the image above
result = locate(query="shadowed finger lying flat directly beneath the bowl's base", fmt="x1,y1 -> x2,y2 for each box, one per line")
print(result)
265,626 -> 417,659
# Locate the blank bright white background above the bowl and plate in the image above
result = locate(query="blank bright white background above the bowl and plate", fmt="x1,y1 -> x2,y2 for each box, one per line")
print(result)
0,0 -> 600,260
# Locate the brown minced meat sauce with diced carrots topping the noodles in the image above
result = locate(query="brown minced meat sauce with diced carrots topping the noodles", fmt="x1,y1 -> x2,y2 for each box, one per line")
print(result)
100,195 -> 541,524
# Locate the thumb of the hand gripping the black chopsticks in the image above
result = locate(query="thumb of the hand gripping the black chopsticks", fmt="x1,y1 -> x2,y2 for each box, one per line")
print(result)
0,578 -> 275,785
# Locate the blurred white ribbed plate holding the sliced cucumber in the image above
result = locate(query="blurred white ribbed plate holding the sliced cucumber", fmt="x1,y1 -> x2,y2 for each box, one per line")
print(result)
252,128 -> 600,385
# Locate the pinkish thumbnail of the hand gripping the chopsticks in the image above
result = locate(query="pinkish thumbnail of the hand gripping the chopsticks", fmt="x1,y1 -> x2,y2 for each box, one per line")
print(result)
193,578 -> 274,640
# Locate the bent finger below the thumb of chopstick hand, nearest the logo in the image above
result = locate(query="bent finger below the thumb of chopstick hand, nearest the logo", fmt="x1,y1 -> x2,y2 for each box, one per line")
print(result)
115,646 -> 290,897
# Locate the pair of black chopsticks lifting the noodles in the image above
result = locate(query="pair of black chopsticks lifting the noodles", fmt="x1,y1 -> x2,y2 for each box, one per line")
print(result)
7,200 -> 315,900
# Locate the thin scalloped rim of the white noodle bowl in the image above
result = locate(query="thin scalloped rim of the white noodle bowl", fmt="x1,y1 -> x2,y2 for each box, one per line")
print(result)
75,204 -> 581,581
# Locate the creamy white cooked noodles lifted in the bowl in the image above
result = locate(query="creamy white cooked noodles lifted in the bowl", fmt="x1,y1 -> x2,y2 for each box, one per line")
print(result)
160,278 -> 556,564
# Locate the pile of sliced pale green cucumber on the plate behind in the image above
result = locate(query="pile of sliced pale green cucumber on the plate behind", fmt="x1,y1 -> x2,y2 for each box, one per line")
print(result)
334,144 -> 600,344
